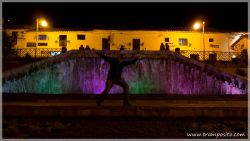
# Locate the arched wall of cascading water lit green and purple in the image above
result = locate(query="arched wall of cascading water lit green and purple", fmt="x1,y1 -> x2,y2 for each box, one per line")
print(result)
2,51 -> 247,94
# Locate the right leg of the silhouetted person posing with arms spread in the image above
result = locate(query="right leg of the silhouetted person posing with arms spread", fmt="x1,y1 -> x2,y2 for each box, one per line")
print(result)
115,79 -> 130,106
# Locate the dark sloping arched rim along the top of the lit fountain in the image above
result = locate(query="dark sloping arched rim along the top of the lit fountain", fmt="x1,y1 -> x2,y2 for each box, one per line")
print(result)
2,50 -> 248,90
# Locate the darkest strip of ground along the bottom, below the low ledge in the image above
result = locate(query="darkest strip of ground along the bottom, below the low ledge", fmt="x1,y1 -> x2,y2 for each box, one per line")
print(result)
3,117 -> 247,139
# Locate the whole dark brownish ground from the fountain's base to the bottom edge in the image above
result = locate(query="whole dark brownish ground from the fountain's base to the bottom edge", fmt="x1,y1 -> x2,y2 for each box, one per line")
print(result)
3,94 -> 247,139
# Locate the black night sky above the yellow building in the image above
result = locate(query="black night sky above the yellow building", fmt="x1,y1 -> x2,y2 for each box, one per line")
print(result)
3,2 -> 248,31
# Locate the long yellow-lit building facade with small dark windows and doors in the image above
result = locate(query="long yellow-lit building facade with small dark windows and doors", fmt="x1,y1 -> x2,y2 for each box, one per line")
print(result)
3,29 -> 249,57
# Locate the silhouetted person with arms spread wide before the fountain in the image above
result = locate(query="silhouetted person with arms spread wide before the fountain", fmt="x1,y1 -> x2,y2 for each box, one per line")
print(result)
97,52 -> 139,106
